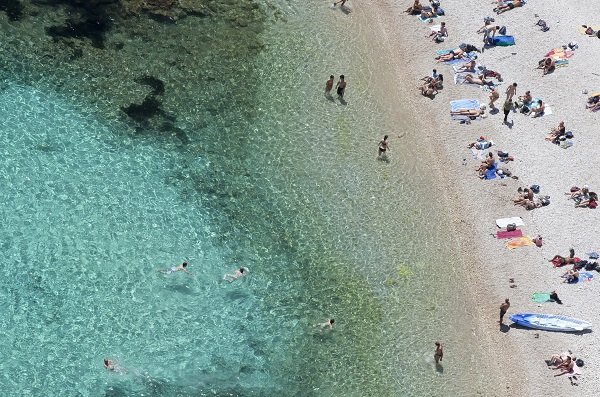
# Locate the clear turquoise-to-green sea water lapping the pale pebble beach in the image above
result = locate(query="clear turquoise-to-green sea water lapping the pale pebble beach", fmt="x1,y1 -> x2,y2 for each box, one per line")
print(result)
0,1 -> 496,396
